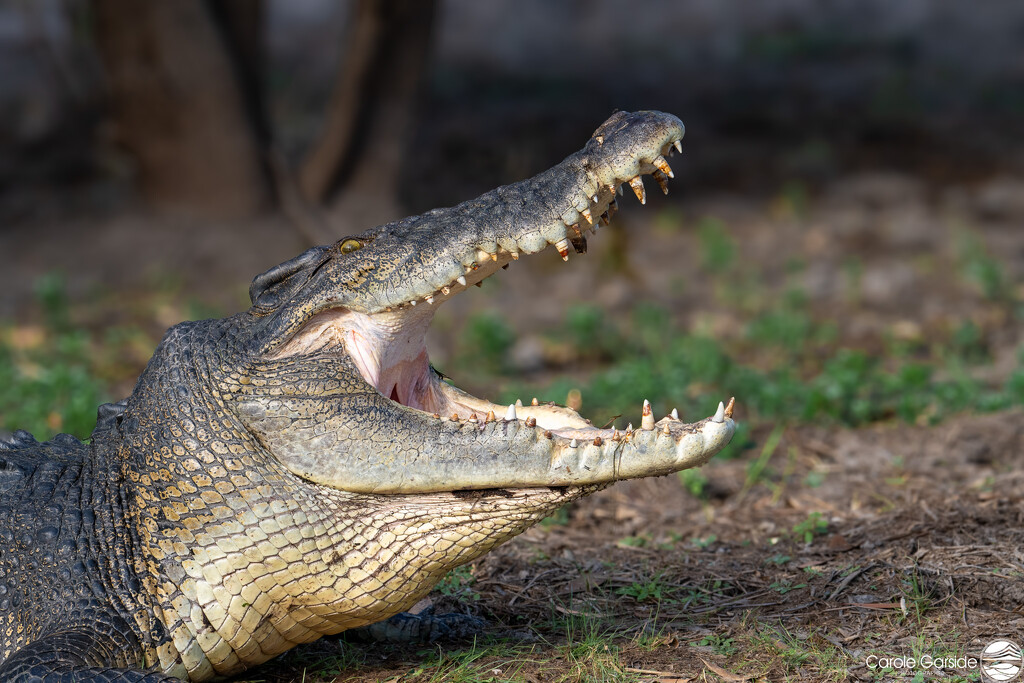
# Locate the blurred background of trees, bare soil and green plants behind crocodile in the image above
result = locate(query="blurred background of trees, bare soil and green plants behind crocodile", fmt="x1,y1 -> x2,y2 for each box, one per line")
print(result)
0,0 -> 1024,449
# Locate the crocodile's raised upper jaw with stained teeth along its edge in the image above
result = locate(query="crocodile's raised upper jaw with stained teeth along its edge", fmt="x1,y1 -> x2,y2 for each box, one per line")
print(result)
323,112 -> 685,313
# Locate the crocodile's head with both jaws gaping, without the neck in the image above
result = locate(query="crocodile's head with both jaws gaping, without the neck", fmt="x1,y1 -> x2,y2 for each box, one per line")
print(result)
237,112 -> 733,494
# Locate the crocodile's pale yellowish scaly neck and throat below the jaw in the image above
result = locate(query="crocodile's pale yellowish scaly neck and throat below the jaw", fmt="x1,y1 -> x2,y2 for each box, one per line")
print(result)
121,324 -> 589,680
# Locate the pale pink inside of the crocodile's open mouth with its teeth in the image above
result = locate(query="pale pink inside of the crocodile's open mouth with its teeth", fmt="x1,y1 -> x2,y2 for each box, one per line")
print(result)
274,141 -> 732,443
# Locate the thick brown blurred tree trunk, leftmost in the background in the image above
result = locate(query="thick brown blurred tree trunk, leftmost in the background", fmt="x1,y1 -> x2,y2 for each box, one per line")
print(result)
93,0 -> 269,217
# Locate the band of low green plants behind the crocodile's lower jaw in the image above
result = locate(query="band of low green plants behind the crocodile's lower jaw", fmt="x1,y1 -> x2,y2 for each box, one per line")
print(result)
466,291 -> 1024,450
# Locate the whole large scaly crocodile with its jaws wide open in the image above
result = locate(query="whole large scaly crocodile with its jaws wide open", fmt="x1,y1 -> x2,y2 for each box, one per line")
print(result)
0,112 -> 734,683
